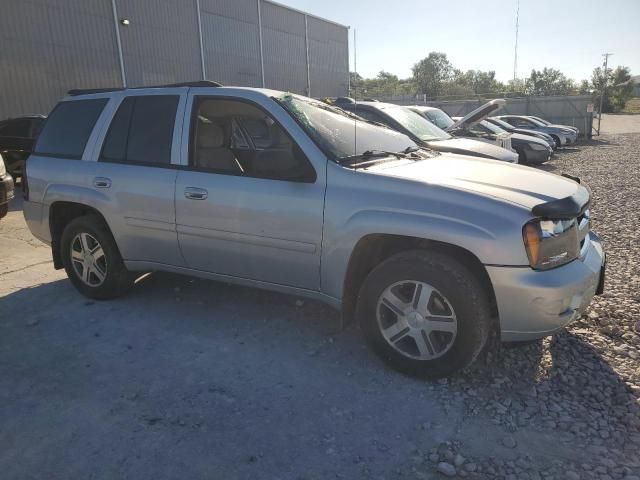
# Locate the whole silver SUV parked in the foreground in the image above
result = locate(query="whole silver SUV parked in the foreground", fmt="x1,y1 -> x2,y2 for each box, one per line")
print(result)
24,82 -> 604,377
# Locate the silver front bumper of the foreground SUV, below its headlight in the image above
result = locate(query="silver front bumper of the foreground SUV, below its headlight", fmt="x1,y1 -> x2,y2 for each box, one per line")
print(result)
487,232 -> 605,342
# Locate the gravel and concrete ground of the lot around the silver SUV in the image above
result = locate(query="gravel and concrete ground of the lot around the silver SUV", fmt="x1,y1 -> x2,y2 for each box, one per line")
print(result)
0,134 -> 640,480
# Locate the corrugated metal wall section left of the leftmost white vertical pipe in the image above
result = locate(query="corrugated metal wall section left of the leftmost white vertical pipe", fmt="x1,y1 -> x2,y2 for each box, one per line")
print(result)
0,0 -> 121,119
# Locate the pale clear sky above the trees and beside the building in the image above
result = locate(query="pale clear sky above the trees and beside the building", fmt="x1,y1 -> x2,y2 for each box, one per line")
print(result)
278,0 -> 640,82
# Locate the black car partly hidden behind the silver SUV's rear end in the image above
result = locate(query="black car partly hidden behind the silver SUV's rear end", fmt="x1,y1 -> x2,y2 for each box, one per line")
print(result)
0,115 -> 46,177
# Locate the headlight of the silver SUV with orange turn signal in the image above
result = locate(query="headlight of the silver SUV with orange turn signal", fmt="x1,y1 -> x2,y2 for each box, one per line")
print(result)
522,219 -> 580,270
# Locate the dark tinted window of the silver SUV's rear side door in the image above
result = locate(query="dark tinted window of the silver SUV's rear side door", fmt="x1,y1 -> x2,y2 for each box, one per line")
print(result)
100,95 -> 179,165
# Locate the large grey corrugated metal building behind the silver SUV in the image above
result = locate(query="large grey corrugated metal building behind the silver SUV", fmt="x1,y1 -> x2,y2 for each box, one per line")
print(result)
0,0 -> 349,119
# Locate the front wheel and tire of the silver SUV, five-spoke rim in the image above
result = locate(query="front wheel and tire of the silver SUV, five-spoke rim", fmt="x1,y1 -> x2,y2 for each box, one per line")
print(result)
356,250 -> 491,378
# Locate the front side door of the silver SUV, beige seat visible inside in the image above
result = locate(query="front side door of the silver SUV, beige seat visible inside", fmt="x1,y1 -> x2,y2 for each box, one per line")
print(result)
176,95 -> 326,290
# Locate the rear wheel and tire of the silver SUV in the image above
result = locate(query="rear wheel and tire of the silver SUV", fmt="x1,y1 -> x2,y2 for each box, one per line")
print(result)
60,215 -> 133,300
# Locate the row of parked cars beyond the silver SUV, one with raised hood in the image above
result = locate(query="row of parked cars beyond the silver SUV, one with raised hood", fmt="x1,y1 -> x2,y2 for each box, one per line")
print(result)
325,97 -> 579,164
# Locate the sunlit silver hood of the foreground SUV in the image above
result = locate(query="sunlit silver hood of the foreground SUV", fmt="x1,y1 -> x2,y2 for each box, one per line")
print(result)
367,154 -> 584,209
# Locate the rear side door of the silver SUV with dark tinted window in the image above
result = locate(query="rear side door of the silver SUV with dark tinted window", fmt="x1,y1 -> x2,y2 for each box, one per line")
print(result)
90,89 -> 186,267
